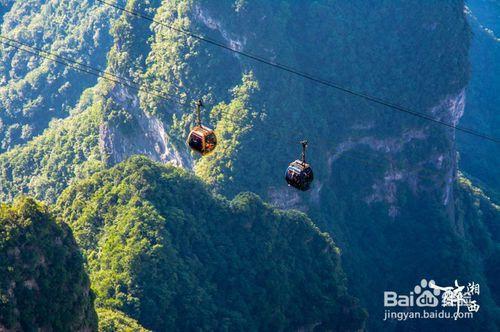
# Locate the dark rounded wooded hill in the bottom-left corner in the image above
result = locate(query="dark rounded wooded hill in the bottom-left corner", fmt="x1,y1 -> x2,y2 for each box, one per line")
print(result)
0,198 -> 97,331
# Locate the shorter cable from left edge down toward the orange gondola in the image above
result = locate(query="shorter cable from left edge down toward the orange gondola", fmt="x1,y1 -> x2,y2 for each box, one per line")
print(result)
0,35 -> 186,107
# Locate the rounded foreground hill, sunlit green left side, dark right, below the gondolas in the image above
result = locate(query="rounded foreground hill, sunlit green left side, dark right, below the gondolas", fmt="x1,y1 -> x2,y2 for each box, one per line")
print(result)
57,157 -> 365,331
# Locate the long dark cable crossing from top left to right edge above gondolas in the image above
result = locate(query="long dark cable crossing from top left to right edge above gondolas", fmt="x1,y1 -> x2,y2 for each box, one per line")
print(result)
96,0 -> 500,144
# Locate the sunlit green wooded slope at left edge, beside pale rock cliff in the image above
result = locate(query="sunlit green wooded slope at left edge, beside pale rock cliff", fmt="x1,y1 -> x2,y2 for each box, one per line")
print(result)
0,98 -> 105,202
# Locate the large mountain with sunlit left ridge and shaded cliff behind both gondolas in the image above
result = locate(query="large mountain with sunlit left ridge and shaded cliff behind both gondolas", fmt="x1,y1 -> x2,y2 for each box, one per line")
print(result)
0,0 -> 499,330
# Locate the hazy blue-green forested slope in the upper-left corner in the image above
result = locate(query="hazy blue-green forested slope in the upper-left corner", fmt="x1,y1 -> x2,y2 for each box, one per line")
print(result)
0,0 -> 116,152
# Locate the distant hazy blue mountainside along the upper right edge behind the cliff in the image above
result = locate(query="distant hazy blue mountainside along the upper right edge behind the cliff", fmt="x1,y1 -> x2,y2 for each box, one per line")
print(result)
458,0 -> 500,201
